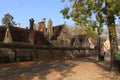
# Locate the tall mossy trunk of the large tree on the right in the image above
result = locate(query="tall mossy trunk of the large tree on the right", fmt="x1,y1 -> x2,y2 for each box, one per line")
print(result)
107,14 -> 118,70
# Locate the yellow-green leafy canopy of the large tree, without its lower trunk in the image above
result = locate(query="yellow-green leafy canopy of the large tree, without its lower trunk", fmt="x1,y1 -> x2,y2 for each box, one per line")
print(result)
60,0 -> 120,25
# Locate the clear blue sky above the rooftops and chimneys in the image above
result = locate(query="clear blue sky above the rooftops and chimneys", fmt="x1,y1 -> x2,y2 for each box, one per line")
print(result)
0,0 -> 74,27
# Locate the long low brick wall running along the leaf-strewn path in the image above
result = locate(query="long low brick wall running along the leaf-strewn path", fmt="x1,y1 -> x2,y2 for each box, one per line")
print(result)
0,49 -> 97,61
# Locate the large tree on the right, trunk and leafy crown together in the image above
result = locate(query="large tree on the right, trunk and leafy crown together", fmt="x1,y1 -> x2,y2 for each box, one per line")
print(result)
60,0 -> 120,69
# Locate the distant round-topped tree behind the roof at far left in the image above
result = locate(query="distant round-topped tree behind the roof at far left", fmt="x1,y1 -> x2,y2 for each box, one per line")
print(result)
2,13 -> 15,26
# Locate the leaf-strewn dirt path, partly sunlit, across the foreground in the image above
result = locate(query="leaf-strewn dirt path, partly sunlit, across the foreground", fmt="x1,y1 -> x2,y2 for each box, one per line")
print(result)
0,58 -> 120,80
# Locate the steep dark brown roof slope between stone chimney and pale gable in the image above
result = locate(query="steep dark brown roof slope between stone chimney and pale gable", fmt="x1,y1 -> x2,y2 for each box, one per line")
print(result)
51,24 -> 64,40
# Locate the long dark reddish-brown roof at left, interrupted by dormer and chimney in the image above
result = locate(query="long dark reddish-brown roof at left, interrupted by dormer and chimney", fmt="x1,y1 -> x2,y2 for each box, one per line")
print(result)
0,26 -> 51,46
